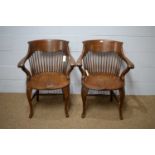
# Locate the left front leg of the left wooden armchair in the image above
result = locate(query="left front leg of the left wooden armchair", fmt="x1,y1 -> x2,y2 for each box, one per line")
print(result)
26,88 -> 33,118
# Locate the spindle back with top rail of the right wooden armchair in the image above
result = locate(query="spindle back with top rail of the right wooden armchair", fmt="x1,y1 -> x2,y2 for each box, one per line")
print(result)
82,40 -> 123,76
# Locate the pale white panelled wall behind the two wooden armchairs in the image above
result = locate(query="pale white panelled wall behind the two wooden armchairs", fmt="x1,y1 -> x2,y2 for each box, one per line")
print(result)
0,27 -> 155,95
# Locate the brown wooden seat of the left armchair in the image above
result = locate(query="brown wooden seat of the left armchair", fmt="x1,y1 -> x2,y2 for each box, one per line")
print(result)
27,72 -> 69,89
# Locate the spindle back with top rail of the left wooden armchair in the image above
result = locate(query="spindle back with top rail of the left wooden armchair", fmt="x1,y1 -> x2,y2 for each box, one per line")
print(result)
28,40 -> 69,75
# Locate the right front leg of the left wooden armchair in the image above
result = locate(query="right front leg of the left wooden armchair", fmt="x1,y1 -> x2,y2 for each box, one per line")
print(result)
62,86 -> 70,117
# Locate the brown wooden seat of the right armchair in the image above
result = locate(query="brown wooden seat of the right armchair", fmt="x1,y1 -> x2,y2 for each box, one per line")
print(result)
83,73 -> 124,90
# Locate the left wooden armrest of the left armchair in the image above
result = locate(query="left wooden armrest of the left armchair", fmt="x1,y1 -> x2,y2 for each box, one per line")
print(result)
17,56 -> 31,79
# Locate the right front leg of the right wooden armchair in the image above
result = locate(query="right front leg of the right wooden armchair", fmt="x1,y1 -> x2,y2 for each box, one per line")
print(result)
119,88 -> 125,120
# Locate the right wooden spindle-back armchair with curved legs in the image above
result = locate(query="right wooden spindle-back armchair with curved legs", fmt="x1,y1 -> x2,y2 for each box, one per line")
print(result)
77,40 -> 134,119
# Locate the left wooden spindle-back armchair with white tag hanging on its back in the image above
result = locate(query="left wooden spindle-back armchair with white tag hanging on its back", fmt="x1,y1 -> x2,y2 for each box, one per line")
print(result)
18,40 -> 76,118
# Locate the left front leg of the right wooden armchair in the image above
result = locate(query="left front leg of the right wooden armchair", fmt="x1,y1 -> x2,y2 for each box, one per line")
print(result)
81,86 -> 88,118
